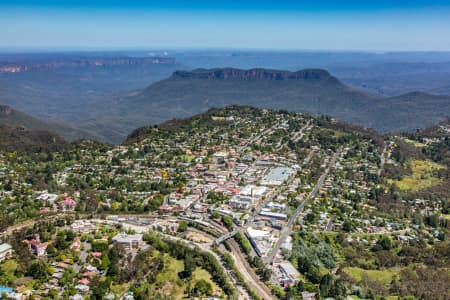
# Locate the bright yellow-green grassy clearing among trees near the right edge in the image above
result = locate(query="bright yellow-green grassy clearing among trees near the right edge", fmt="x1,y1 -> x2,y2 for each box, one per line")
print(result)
393,160 -> 445,191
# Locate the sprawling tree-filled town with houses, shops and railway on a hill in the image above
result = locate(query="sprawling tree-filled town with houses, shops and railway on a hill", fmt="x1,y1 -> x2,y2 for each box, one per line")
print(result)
0,106 -> 448,300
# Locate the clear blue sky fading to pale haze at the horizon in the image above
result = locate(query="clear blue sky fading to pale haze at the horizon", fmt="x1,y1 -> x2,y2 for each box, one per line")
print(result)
0,0 -> 450,51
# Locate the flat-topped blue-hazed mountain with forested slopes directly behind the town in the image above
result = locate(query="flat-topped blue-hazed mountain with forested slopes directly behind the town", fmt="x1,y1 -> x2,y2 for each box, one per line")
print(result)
117,68 -> 450,132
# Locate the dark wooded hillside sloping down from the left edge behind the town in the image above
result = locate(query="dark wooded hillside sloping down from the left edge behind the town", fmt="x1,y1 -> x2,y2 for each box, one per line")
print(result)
0,105 -> 96,140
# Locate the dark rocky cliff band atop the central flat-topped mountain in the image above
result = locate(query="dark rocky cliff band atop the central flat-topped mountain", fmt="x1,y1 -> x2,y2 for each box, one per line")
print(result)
172,68 -> 339,82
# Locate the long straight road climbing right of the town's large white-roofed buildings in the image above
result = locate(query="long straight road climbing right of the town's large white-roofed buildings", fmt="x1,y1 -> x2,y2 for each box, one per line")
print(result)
263,147 -> 342,264
